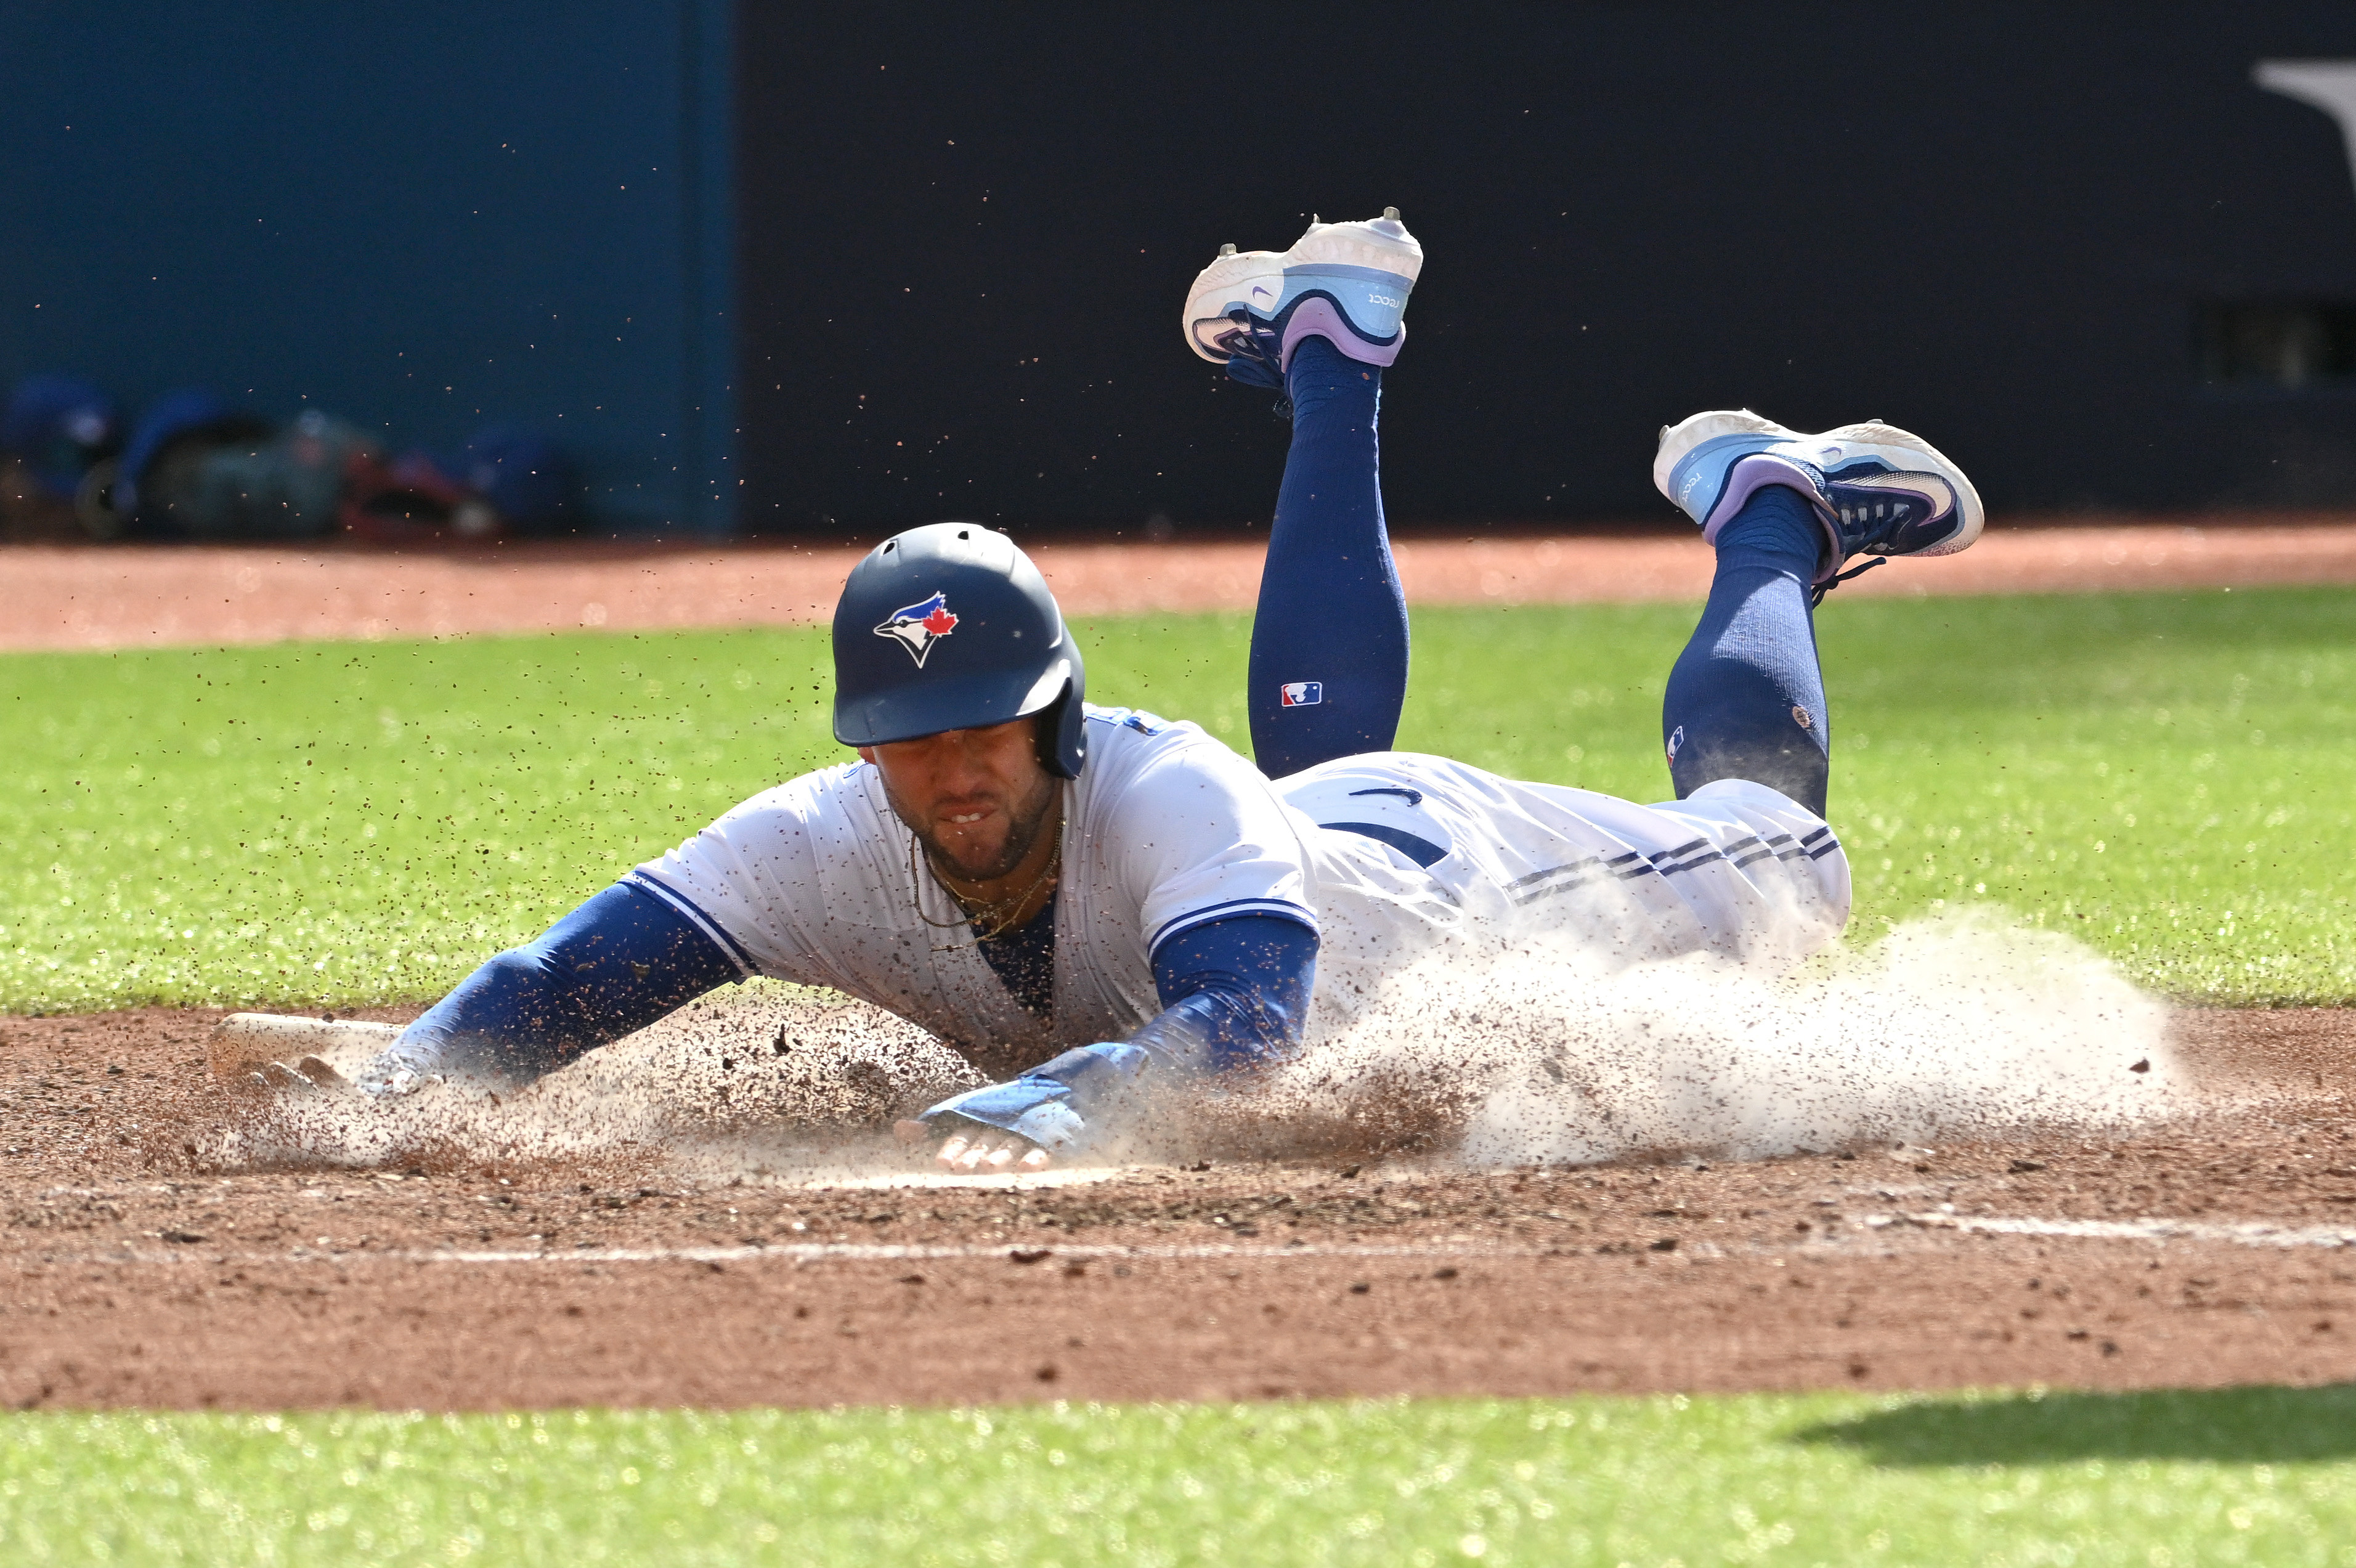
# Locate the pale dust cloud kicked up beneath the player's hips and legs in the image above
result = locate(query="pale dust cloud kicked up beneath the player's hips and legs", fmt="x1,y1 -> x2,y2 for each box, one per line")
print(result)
1253,899 -> 2188,1168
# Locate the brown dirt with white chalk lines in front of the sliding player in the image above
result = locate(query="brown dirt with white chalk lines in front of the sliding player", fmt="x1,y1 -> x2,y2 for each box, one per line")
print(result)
0,1010 -> 2356,1408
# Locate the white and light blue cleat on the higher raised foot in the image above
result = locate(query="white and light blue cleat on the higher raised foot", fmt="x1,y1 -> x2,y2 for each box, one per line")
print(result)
1183,207 -> 1423,386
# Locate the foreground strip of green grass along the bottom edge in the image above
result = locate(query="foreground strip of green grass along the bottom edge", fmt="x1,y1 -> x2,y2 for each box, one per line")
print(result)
14,1387 -> 2356,1568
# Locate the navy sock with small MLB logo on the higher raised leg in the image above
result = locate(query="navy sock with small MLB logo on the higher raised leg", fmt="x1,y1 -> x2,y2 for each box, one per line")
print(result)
1246,336 -> 1407,779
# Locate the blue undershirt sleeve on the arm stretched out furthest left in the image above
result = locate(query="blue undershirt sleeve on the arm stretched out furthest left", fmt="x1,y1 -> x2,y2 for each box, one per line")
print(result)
394,883 -> 742,1083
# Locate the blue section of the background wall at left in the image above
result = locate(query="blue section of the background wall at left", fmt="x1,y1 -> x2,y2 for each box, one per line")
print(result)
0,0 -> 737,530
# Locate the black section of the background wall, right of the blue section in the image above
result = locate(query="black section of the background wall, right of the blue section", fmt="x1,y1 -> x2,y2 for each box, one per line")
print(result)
737,0 -> 2356,534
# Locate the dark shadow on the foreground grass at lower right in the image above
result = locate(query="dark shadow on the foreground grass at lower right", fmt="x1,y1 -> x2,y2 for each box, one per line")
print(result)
1790,1384 -> 2356,1469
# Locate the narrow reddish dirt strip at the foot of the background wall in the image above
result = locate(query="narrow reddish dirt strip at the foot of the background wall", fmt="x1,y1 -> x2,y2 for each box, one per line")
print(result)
14,516 -> 2356,650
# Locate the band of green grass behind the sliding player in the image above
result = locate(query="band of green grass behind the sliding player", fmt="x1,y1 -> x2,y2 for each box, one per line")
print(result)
0,579 -> 2356,1010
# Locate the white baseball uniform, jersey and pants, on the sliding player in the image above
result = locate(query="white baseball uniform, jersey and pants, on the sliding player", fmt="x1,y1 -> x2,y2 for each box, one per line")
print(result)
629,706 -> 1850,1074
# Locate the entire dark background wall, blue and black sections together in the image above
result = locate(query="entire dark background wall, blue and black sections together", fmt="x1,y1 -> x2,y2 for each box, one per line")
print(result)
18,0 -> 2356,537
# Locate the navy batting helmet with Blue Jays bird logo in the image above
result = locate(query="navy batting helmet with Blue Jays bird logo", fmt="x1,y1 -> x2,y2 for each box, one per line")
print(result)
834,522 -> 1089,779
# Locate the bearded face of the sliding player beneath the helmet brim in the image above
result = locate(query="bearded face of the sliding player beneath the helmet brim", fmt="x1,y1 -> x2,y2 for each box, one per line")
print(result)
860,718 -> 1055,883
